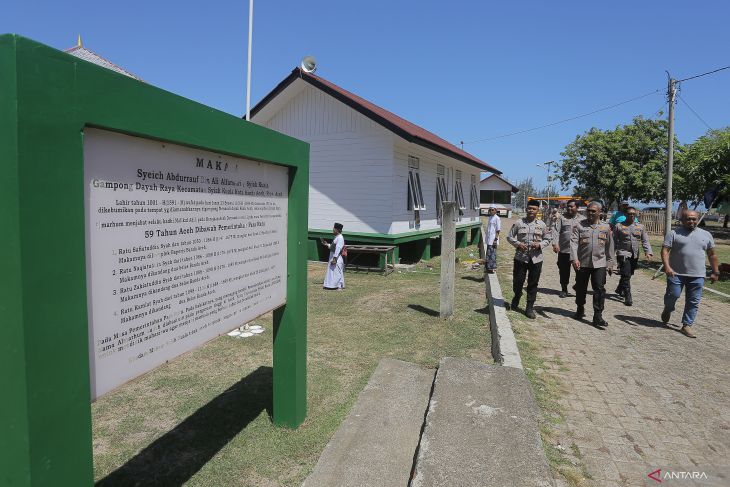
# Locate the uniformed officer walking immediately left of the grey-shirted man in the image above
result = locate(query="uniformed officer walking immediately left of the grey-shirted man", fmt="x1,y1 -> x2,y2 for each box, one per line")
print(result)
613,206 -> 654,306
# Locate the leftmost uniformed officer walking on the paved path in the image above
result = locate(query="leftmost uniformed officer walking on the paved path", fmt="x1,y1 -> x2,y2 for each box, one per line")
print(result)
507,200 -> 551,319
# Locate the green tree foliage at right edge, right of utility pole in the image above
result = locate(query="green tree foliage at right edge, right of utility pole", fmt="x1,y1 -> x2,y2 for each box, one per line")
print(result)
673,127 -> 730,205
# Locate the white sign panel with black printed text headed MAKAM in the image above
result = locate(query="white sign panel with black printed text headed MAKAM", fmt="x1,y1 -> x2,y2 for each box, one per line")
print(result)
84,129 -> 289,399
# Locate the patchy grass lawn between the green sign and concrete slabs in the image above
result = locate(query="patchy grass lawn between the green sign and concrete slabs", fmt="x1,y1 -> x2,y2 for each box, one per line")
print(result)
92,247 -> 493,487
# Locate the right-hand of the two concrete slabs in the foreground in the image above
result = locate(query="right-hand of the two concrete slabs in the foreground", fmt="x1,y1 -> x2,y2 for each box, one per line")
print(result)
411,358 -> 553,487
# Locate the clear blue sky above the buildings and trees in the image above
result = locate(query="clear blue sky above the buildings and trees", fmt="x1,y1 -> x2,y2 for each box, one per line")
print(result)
5,0 -> 730,190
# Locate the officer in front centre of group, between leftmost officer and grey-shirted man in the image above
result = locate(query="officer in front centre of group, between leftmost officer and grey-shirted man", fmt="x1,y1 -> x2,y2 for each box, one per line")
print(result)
570,201 -> 613,327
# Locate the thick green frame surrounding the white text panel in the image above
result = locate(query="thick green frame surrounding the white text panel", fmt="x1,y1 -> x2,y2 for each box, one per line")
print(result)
0,34 -> 309,487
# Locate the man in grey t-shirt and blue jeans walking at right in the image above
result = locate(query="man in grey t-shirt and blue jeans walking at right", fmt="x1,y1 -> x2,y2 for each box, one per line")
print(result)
662,211 -> 720,338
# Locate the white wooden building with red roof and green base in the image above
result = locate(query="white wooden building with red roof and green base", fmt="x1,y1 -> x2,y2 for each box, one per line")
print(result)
251,68 -> 499,260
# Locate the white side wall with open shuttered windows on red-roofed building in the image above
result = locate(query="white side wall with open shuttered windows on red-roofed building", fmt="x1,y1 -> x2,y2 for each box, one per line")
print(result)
389,137 -> 480,233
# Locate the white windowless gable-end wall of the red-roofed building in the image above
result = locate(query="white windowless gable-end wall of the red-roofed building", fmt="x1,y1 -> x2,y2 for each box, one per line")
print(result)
257,85 -> 392,233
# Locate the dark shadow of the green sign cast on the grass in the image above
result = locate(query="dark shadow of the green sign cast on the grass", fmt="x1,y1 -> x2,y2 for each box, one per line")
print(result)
96,367 -> 273,487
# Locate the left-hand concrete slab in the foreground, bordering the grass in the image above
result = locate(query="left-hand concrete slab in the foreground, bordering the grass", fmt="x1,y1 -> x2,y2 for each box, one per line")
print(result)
303,359 -> 435,487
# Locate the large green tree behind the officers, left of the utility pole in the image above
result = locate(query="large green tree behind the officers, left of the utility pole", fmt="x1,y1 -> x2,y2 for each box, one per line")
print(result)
558,116 -> 668,211
